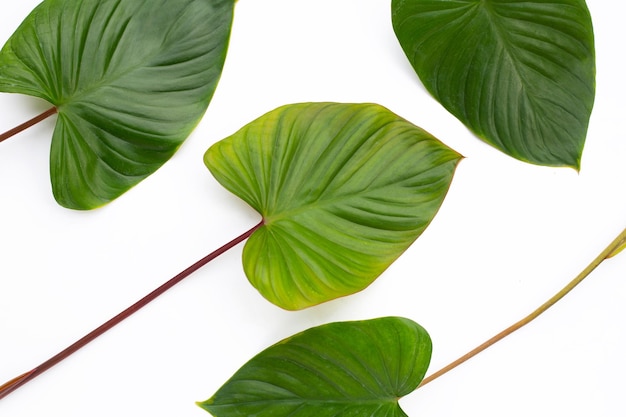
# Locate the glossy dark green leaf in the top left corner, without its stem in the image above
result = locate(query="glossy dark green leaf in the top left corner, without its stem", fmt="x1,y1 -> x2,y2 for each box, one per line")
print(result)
0,0 -> 234,209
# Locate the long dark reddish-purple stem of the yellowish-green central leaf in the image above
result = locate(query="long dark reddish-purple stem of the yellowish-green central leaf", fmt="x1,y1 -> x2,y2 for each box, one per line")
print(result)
0,221 -> 263,399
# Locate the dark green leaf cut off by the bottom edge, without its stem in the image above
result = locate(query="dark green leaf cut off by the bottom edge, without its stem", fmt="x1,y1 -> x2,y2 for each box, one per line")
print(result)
199,317 -> 432,417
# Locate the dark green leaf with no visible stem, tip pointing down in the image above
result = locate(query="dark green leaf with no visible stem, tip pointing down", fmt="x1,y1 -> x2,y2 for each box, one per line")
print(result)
392,0 -> 595,169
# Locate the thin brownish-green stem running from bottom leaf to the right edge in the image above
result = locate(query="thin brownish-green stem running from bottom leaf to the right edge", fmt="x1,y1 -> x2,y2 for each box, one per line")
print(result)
418,224 -> 626,388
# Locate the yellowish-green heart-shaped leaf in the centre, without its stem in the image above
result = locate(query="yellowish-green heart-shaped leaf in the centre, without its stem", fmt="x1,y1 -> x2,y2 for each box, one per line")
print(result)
205,103 -> 461,310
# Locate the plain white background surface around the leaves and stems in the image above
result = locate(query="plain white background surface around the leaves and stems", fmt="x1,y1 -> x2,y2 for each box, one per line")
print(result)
0,0 -> 626,417
